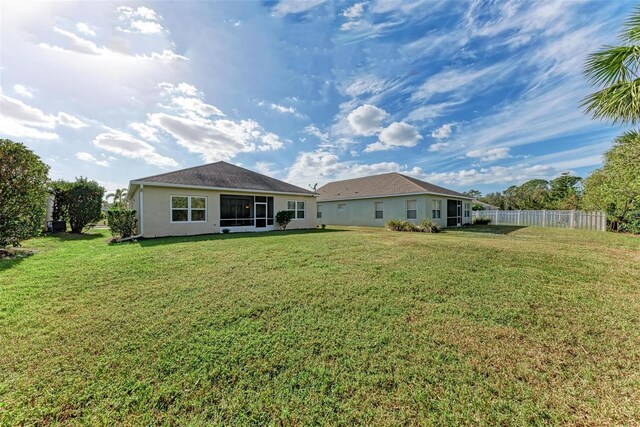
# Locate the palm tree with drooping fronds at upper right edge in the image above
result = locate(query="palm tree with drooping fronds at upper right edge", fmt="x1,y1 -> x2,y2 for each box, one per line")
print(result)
581,6 -> 640,125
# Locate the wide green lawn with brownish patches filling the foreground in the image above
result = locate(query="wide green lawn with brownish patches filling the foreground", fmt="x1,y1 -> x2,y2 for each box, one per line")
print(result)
0,227 -> 640,426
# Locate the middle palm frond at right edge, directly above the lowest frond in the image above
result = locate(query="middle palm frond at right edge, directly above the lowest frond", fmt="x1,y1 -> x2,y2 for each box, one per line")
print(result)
584,45 -> 640,87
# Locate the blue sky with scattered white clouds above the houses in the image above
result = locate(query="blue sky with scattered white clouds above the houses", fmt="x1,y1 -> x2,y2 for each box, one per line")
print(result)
0,0 -> 634,192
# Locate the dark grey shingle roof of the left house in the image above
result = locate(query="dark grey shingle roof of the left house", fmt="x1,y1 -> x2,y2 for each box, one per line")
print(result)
132,162 -> 313,195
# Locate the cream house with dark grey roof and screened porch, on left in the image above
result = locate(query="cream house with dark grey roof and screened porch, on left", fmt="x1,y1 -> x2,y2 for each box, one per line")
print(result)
128,162 -> 316,237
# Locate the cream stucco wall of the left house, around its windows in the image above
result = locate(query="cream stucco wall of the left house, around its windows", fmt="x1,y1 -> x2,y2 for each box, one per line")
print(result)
131,185 -> 316,237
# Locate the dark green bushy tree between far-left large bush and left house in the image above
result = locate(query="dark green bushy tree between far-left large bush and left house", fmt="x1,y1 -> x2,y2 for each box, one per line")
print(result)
53,177 -> 104,233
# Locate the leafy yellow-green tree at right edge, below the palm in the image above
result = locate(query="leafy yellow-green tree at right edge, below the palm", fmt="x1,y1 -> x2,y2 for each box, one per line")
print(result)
584,131 -> 640,233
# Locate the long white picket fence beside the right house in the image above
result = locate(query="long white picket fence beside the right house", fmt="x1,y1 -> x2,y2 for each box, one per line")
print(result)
471,210 -> 607,231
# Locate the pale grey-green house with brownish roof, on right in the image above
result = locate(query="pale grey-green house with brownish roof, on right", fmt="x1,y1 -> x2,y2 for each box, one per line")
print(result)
317,173 -> 472,227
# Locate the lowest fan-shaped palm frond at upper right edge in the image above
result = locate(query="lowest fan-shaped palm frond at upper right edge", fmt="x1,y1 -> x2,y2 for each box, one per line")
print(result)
580,79 -> 640,125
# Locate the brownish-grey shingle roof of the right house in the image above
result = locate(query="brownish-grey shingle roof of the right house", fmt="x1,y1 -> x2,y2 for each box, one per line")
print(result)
318,172 -> 471,202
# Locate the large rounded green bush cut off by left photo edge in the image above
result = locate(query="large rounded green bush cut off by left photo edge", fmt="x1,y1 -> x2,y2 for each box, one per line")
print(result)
0,139 -> 49,247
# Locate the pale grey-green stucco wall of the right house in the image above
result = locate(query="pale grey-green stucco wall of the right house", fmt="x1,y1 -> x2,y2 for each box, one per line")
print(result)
317,195 -> 471,227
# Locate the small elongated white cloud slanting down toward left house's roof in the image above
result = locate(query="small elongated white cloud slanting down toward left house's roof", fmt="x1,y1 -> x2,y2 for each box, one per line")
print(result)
93,130 -> 178,167
